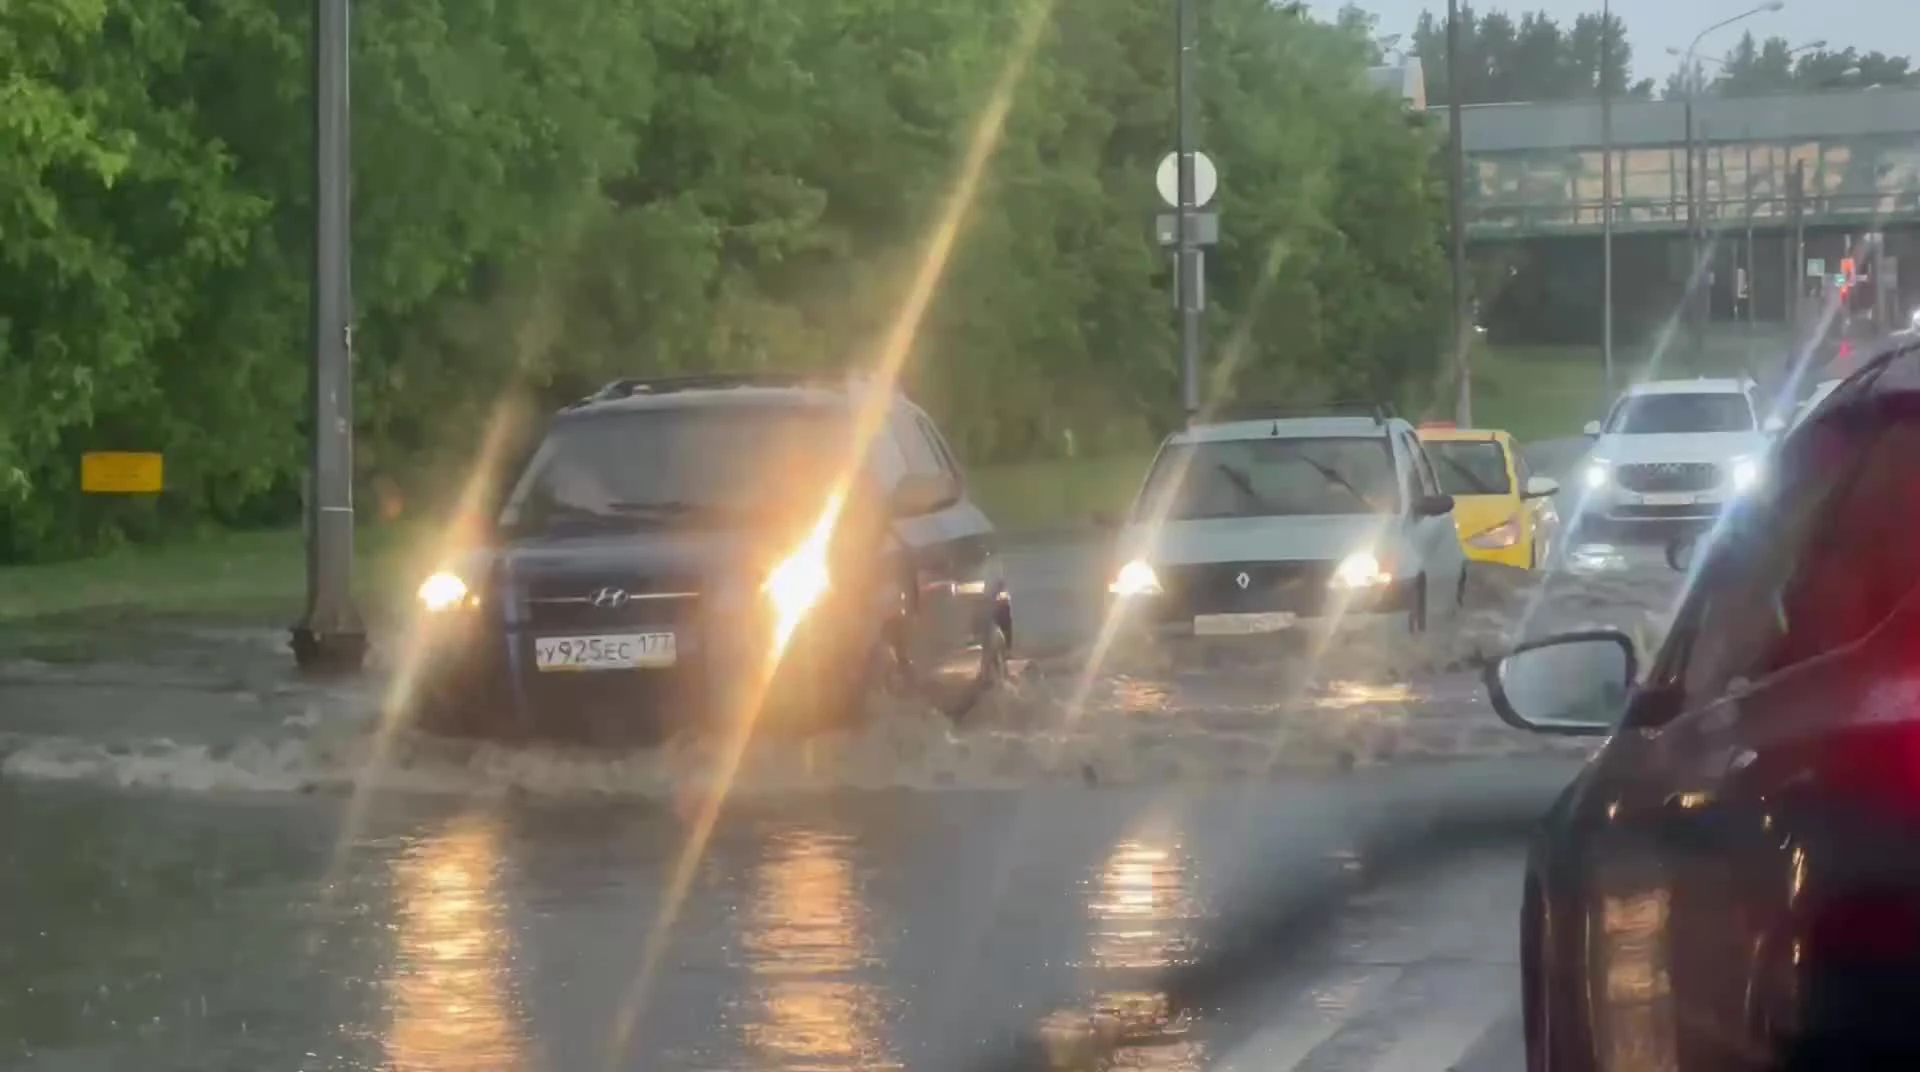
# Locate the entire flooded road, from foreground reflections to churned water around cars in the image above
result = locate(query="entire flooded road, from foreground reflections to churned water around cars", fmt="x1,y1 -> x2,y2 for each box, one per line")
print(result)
0,518 -> 1676,1072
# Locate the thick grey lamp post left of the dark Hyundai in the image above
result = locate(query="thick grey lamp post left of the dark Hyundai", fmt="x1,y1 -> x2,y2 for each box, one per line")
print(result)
292,0 -> 367,672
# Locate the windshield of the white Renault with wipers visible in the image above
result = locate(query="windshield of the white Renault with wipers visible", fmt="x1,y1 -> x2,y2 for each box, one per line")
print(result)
1139,436 -> 1400,521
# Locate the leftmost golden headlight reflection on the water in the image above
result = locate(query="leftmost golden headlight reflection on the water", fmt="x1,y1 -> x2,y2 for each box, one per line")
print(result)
384,815 -> 538,1072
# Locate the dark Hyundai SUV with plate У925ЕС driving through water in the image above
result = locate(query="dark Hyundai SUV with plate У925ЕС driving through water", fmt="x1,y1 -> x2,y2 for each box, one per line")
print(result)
413,375 -> 1014,738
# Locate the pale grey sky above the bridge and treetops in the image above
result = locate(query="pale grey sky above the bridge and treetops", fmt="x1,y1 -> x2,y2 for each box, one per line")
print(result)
1309,0 -> 1920,79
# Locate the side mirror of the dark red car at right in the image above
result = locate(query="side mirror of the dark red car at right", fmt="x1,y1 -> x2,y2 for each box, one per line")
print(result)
1486,628 -> 1640,738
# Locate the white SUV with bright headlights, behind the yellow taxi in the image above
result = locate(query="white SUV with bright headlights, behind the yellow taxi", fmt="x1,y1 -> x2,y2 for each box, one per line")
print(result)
1580,378 -> 1786,542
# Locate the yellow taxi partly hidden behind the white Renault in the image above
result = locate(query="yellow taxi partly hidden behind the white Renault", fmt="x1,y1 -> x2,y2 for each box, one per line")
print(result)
1419,423 -> 1561,569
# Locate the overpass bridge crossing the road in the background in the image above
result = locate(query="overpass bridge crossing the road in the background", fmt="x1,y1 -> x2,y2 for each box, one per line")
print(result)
1428,88 -> 1920,336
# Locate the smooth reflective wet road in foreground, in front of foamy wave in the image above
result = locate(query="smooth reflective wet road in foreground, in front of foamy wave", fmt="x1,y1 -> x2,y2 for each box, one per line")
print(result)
0,761 -> 1571,1072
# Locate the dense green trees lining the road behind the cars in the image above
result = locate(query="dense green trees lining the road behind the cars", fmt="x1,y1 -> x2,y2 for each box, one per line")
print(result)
0,0 -> 1448,561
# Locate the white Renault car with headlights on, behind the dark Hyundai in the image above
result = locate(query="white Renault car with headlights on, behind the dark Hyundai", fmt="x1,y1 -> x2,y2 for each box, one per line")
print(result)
1108,411 -> 1467,636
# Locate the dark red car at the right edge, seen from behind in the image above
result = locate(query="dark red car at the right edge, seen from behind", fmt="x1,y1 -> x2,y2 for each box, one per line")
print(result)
1488,340 -> 1920,1072
